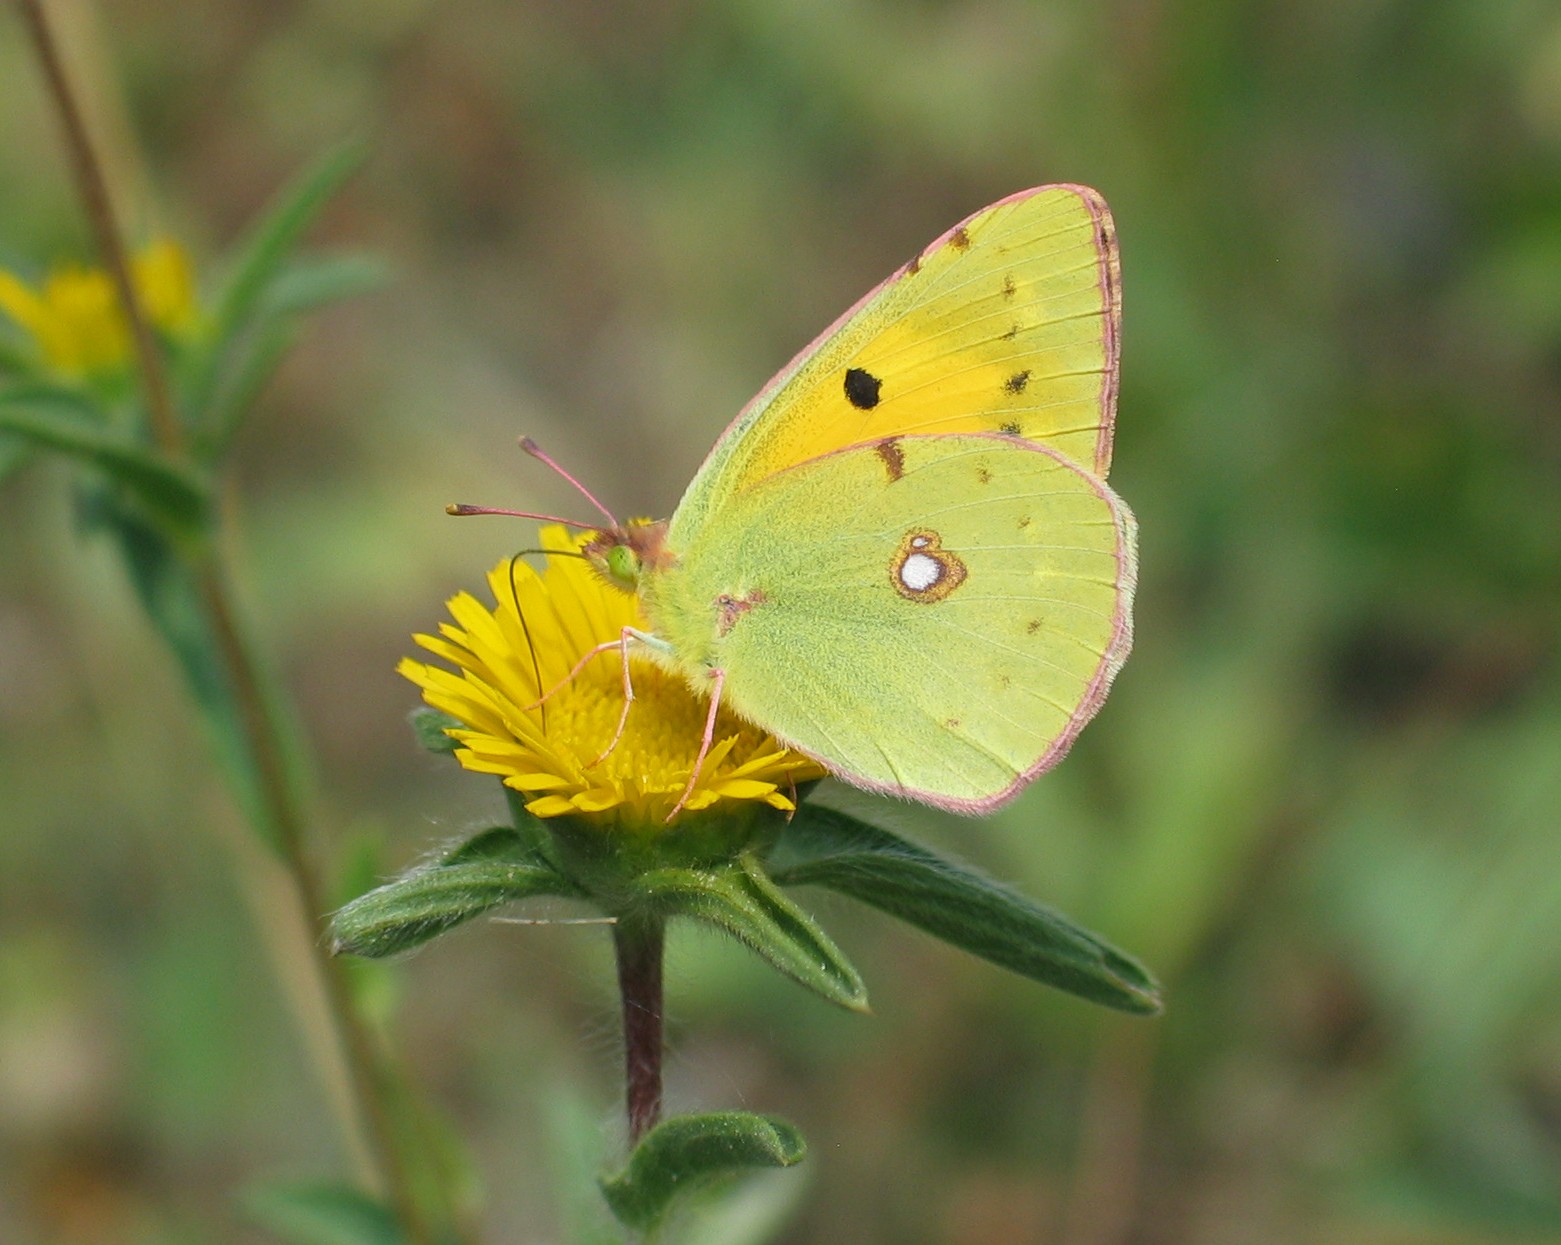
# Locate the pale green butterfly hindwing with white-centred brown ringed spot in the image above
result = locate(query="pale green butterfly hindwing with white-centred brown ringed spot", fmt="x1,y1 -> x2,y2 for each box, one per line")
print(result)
642,434 -> 1135,811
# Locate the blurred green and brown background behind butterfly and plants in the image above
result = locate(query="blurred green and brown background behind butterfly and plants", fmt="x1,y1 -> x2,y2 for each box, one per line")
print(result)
0,0 -> 1561,1245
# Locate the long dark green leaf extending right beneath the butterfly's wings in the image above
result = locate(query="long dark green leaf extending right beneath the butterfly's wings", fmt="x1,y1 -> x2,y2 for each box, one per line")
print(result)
771,805 -> 1161,1014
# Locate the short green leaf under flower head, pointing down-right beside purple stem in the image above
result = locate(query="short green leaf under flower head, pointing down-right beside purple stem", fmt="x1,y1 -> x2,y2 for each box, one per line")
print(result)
634,857 -> 868,1011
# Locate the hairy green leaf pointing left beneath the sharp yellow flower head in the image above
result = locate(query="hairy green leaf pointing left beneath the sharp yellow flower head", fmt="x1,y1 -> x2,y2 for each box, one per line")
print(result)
331,825 -> 585,959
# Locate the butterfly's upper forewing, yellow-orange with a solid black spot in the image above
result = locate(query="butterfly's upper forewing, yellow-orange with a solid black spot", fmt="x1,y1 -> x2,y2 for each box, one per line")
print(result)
673,186 -> 1121,538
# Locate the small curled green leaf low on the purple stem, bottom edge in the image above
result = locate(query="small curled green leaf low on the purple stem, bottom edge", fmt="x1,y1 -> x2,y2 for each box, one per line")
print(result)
601,1111 -> 807,1233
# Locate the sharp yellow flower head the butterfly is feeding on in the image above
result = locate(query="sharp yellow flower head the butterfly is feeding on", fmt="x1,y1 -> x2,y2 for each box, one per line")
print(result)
398,527 -> 824,828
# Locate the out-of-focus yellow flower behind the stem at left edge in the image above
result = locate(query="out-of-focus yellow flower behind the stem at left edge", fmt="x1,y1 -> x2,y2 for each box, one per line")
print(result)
0,240 -> 200,378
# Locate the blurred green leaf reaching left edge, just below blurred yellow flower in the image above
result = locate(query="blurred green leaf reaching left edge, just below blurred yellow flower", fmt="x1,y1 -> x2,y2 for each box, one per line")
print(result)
0,384 -> 208,535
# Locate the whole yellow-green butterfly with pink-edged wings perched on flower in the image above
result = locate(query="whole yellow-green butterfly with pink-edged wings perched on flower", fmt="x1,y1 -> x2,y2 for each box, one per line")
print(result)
451,186 -> 1136,814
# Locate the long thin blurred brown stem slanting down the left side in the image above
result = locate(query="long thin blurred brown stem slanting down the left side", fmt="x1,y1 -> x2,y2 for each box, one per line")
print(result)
19,0 -> 432,1245
